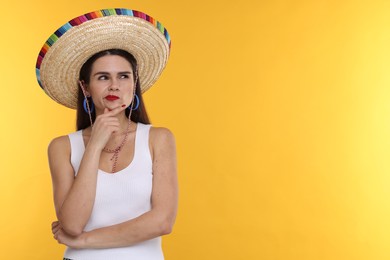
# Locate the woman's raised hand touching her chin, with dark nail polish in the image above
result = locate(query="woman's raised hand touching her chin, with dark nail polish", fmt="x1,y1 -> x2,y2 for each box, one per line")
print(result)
89,105 -> 126,150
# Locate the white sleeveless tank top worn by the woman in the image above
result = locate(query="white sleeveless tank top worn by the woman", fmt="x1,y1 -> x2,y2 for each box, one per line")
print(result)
64,123 -> 164,260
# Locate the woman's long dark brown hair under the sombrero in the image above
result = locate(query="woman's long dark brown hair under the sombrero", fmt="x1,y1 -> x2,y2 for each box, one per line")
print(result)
76,49 -> 150,130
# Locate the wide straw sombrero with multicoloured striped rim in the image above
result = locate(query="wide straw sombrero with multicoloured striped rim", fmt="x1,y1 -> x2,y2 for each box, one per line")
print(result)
36,8 -> 171,109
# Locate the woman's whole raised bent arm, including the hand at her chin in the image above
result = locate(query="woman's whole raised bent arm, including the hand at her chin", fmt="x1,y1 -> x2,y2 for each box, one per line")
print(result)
48,105 -> 126,236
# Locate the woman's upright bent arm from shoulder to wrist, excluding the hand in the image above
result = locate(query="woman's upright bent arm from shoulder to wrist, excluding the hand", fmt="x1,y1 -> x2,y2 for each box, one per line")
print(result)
48,136 -> 101,236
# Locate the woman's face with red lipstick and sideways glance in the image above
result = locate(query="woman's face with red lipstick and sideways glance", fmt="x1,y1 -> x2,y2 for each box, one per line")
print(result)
87,55 -> 135,113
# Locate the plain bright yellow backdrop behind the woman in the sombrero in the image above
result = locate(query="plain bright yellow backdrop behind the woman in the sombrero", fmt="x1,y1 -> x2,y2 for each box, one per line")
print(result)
0,0 -> 390,260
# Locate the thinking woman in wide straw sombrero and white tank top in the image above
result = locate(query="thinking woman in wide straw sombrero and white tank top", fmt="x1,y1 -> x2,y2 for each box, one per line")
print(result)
37,9 -> 177,260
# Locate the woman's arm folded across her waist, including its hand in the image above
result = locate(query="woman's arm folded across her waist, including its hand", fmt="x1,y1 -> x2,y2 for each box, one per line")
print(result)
55,128 -> 178,248
